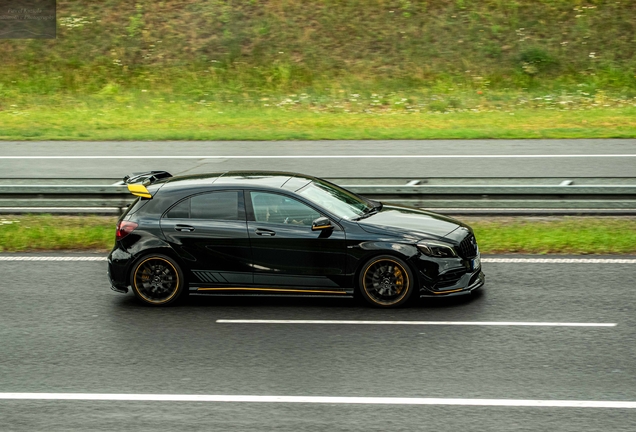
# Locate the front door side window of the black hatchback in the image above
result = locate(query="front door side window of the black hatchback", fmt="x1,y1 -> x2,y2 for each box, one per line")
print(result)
250,192 -> 320,226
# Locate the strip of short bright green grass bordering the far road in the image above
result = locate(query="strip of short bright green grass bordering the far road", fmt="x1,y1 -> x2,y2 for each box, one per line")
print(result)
0,99 -> 636,140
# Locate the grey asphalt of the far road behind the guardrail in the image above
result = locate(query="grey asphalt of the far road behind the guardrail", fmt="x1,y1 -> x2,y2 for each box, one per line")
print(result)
0,139 -> 636,178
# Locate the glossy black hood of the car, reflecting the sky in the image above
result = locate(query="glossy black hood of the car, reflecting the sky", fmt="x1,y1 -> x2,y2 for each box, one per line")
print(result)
358,205 -> 466,238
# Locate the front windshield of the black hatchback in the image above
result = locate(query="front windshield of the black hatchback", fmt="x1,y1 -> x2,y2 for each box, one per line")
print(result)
297,181 -> 371,219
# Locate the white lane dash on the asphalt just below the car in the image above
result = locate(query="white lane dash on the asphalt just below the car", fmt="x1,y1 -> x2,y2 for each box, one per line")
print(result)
216,319 -> 616,327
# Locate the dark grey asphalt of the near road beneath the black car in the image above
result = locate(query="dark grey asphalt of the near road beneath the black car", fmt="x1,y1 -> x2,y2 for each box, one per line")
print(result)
0,255 -> 636,432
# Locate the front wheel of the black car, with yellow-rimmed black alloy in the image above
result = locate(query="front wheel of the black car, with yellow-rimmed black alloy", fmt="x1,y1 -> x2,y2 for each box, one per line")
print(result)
358,255 -> 415,308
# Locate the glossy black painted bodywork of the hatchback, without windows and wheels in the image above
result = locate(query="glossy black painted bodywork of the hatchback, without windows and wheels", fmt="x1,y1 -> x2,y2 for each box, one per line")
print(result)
108,173 -> 484,297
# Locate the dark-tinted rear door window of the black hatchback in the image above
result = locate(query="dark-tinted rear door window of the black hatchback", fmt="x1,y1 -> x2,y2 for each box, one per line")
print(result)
166,191 -> 244,220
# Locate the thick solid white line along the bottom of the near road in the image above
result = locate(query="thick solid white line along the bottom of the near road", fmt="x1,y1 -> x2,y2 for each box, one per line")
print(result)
0,393 -> 636,409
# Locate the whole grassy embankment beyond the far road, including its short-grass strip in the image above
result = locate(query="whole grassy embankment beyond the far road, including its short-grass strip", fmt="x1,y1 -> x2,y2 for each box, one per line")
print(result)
0,0 -> 636,139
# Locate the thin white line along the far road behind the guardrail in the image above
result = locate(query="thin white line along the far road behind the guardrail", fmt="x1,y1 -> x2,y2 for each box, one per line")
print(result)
0,154 -> 636,159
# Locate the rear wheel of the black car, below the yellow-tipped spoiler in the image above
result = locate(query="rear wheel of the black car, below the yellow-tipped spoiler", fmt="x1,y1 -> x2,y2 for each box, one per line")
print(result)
130,254 -> 187,306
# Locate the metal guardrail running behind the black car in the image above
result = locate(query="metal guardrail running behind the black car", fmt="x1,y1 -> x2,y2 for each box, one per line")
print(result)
0,177 -> 636,215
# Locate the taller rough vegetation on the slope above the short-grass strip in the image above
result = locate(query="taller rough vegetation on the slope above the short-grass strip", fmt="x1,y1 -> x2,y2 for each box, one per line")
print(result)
0,0 -> 636,125
